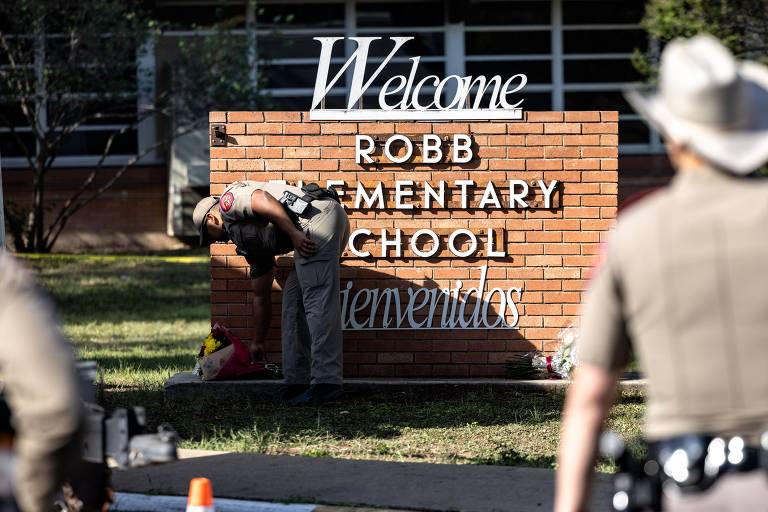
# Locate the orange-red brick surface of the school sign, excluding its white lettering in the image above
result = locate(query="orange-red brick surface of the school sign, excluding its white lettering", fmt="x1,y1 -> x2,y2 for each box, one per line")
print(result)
210,112 -> 618,377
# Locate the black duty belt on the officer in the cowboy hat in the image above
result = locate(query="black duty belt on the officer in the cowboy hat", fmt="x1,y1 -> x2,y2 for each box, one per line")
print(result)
600,432 -> 768,511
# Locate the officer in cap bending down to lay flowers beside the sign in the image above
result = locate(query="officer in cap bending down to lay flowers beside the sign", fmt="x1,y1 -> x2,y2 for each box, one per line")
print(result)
193,181 -> 349,405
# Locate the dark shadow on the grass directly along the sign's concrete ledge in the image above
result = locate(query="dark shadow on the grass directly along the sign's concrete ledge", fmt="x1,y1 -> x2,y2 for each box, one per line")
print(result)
106,388 -> 562,442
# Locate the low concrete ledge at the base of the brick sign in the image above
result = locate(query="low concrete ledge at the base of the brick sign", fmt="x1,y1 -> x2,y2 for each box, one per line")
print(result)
164,372 -> 645,402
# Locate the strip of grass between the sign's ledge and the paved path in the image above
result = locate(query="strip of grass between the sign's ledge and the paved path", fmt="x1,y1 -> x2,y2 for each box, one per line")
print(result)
106,387 -> 642,472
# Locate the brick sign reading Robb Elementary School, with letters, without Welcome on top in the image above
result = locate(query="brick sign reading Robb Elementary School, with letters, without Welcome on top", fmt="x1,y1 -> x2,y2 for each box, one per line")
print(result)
210,112 -> 618,377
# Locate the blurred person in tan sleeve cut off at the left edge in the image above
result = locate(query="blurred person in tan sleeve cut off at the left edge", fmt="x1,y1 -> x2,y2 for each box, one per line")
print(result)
0,254 -> 82,511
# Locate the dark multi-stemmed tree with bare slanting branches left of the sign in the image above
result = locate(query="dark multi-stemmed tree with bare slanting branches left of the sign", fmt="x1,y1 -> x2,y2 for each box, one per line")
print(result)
0,0 -> 263,252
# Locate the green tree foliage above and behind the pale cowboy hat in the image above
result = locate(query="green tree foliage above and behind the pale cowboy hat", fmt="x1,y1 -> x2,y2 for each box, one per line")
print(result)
633,0 -> 768,83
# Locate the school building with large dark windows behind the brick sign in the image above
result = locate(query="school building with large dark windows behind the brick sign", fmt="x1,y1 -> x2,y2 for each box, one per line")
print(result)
0,0 -> 671,250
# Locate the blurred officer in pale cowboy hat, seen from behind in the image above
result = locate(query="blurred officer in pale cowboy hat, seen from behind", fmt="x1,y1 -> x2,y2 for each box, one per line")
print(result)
555,35 -> 768,512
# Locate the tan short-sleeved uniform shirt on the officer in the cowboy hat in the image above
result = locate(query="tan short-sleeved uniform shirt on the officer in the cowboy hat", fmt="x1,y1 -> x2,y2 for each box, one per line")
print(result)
579,168 -> 768,439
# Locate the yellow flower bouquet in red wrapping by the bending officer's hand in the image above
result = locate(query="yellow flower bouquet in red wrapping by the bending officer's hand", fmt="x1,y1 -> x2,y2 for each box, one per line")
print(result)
195,323 -> 282,380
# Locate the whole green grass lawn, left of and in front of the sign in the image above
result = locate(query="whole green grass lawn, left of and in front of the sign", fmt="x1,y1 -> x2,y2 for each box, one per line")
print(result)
21,252 -> 644,470
